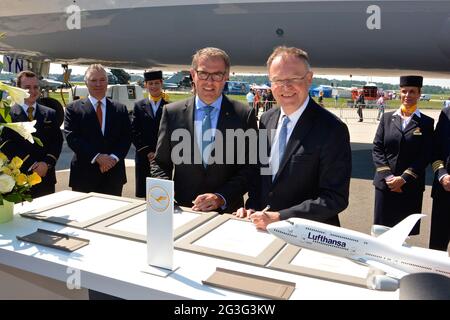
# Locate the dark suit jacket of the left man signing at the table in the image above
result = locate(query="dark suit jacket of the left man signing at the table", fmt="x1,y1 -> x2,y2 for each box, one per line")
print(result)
151,96 -> 257,212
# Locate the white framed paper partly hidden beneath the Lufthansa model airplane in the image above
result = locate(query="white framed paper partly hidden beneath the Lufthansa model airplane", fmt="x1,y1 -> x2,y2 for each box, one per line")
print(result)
291,249 -> 369,278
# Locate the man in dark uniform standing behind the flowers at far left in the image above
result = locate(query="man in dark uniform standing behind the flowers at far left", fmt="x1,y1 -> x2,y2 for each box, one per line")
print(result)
1,71 -> 63,198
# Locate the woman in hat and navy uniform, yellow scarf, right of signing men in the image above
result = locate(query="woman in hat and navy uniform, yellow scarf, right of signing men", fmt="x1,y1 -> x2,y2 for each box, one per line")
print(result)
372,76 -> 434,235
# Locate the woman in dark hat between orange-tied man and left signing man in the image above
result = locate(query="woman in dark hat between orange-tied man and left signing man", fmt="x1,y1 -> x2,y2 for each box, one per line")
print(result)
131,71 -> 168,198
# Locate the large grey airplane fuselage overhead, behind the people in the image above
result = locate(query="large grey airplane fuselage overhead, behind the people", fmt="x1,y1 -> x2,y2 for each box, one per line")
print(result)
0,0 -> 450,76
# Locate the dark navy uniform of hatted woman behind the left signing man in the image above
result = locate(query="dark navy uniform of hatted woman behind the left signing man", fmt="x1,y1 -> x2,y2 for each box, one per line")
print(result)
131,98 -> 167,197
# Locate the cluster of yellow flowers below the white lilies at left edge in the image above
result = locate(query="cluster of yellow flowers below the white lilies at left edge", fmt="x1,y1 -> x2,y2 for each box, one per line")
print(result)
0,152 -> 41,205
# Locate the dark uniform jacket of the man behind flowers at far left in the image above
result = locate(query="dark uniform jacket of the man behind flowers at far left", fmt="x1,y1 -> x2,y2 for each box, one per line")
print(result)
2,104 -> 63,198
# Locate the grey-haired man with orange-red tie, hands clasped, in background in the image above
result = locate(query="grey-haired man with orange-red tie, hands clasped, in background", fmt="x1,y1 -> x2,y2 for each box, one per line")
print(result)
64,64 -> 131,196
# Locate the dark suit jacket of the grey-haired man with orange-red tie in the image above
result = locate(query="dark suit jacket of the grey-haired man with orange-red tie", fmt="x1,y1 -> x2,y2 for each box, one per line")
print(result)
64,98 -> 131,192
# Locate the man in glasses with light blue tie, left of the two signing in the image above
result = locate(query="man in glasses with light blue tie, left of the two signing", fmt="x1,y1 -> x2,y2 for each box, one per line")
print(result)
151,48 -> 256,212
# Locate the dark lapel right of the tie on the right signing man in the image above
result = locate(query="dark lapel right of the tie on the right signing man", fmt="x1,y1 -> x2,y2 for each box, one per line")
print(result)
274,100 -> 317,183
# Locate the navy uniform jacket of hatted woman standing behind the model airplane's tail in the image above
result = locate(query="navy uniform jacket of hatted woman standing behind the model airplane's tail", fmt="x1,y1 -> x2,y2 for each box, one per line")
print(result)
372,112 -> 434,233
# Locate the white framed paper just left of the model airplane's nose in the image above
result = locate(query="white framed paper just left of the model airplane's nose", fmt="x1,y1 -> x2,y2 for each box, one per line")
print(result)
193,219 -> 274,257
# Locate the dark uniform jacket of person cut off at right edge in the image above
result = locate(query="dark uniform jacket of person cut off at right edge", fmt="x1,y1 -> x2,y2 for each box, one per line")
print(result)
431,108 -> 450,198
